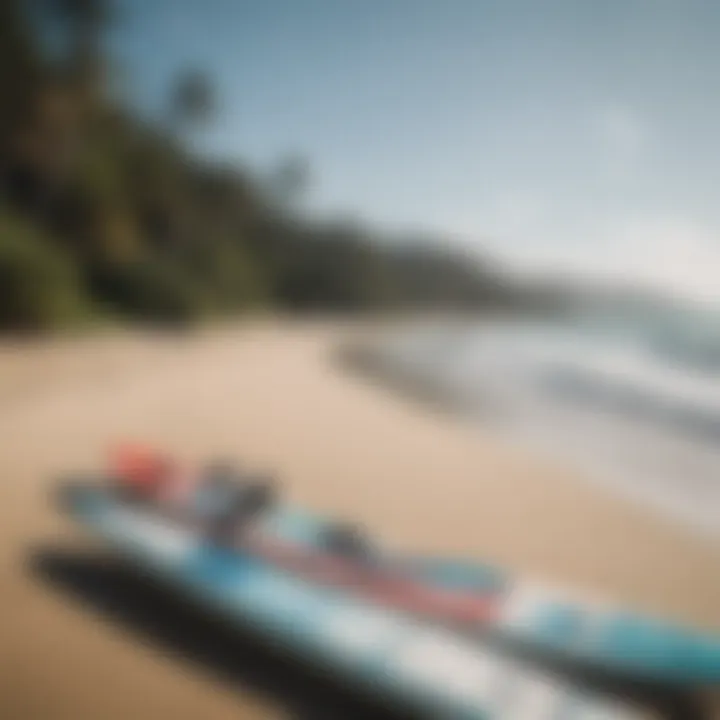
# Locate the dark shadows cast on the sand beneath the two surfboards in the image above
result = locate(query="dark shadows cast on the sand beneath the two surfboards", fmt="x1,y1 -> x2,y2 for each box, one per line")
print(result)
29,546 -> 711,720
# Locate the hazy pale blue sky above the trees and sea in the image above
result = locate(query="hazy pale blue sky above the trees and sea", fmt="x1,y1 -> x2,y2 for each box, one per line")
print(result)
114,0 -> 720,296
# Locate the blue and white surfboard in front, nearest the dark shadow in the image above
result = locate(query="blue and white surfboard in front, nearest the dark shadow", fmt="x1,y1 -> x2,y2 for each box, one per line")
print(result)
57,486 -> 641,720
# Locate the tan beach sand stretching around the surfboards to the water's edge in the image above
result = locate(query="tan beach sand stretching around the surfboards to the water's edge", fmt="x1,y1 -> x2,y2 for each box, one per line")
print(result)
0,322 -> 720,720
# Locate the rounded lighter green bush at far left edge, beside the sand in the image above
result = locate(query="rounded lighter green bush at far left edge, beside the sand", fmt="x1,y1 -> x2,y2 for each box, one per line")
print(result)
0,211 -> 85,330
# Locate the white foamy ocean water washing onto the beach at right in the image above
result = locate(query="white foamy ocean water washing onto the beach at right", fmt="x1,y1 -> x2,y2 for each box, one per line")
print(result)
377,313 -> 720,537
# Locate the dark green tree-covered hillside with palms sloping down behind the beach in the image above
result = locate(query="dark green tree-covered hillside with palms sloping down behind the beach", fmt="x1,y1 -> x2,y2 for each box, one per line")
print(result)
0,0 -> 512,331
